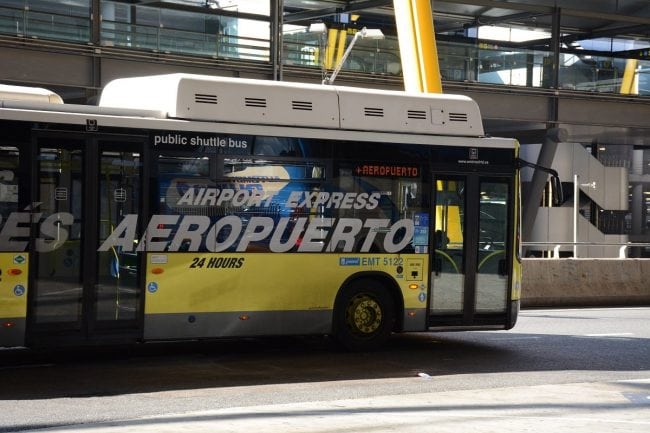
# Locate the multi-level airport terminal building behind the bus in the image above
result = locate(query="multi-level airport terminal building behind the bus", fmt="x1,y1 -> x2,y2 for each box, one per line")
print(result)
0,0 -> 650,258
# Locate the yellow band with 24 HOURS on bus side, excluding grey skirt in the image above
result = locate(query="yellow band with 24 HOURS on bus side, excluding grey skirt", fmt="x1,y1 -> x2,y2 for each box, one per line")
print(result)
145,252 -> 428,314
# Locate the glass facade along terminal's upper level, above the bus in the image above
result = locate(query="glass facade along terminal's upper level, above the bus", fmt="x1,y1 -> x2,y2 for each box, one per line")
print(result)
0,0 -> 650,95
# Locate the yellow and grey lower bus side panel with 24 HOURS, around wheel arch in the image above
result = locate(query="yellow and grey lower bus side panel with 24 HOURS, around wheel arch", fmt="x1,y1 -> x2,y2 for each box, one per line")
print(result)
144,253 -> 428,340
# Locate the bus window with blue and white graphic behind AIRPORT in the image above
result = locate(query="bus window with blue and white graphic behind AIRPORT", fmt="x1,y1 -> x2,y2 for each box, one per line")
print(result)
149,155 -> 325,252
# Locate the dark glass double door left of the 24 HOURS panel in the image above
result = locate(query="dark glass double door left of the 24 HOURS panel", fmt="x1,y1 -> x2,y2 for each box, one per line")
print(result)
28,134 -> 144,345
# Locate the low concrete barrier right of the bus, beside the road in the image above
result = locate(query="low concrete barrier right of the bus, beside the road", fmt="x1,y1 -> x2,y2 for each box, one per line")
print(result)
521,259 -> 650,308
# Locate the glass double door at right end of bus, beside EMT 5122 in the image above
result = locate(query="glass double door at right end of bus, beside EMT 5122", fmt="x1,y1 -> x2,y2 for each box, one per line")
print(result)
429,174 -> 513,325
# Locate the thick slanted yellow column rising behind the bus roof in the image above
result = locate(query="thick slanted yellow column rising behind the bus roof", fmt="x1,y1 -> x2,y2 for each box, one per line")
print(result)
393,0 -> 442,93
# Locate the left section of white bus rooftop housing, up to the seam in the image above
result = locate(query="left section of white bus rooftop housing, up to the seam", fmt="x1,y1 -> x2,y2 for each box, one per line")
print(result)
99,74 -> 339,128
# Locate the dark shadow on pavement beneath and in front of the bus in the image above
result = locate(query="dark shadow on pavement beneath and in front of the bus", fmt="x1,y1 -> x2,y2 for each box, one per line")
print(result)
0,332 -> 650,400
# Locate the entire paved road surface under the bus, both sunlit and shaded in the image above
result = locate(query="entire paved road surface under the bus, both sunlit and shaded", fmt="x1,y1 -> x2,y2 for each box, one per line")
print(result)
0,308 -> 650,433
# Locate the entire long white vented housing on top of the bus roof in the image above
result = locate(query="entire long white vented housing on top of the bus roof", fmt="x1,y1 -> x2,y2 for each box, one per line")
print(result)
99,74 -> 484,137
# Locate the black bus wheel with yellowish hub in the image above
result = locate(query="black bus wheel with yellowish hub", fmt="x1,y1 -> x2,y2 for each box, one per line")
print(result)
335,278 -> 395,350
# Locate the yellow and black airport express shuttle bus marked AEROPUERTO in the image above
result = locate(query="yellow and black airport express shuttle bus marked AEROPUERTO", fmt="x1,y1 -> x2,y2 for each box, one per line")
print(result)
0,74 -> 536,350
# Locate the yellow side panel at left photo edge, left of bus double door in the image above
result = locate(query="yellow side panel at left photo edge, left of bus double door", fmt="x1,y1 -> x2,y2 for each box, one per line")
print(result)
0,252 -> 29,347
